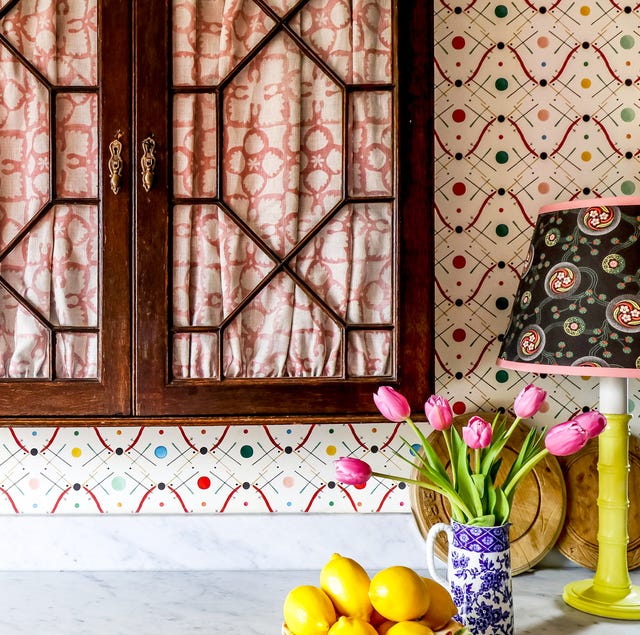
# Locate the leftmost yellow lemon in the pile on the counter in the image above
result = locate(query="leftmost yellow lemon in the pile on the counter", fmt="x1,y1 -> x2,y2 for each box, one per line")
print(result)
282,585 -> 336,635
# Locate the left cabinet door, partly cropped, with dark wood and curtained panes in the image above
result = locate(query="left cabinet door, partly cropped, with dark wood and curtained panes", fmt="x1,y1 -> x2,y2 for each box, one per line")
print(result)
0,0 -> 131,417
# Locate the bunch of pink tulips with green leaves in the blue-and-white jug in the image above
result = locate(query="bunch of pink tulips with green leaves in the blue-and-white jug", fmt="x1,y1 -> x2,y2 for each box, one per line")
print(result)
335,384 -> 607,526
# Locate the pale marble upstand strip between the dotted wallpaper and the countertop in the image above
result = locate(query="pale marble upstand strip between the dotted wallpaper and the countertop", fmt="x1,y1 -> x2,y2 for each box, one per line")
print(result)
0,514 -> 426,571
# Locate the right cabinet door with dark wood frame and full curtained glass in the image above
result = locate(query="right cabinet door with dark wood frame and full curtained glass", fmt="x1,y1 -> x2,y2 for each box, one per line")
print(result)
134,0 -> 432,421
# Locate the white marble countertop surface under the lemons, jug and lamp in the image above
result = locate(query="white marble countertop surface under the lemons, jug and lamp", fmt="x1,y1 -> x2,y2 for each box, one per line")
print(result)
0,567 -> 640,635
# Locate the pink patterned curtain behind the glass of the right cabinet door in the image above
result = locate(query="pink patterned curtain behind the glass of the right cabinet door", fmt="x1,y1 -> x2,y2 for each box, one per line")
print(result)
173,0 -> 395,378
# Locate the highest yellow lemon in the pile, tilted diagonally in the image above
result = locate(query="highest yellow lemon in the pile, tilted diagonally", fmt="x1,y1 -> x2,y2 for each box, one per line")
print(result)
320,553 -> 373,621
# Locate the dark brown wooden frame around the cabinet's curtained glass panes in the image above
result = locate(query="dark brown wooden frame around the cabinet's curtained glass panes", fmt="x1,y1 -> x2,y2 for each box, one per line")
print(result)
0,0 -> 434,425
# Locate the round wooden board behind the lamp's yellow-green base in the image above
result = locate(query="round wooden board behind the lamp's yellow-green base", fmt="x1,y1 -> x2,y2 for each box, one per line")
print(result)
556,435 -> 640,570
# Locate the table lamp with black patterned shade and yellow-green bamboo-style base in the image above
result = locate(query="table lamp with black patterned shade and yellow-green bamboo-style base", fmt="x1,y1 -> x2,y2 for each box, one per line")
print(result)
498,197 -> 640,620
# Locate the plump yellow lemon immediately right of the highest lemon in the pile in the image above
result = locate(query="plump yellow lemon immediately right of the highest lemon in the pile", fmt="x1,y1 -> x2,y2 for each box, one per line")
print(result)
369,565 -> 429,622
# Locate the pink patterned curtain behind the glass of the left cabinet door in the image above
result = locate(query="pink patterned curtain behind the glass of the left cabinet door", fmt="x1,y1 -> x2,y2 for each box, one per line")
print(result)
0,0 -> 99,378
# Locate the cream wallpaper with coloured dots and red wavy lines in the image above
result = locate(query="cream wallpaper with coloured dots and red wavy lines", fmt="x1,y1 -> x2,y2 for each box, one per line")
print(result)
0,0 -> 640,514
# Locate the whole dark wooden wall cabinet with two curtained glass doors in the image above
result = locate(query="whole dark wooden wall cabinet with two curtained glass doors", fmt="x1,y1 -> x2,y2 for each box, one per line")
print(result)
0,0 -> 433,425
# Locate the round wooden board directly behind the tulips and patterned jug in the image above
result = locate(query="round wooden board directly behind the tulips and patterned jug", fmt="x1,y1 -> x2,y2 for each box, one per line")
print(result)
410,412 -> 566,575
